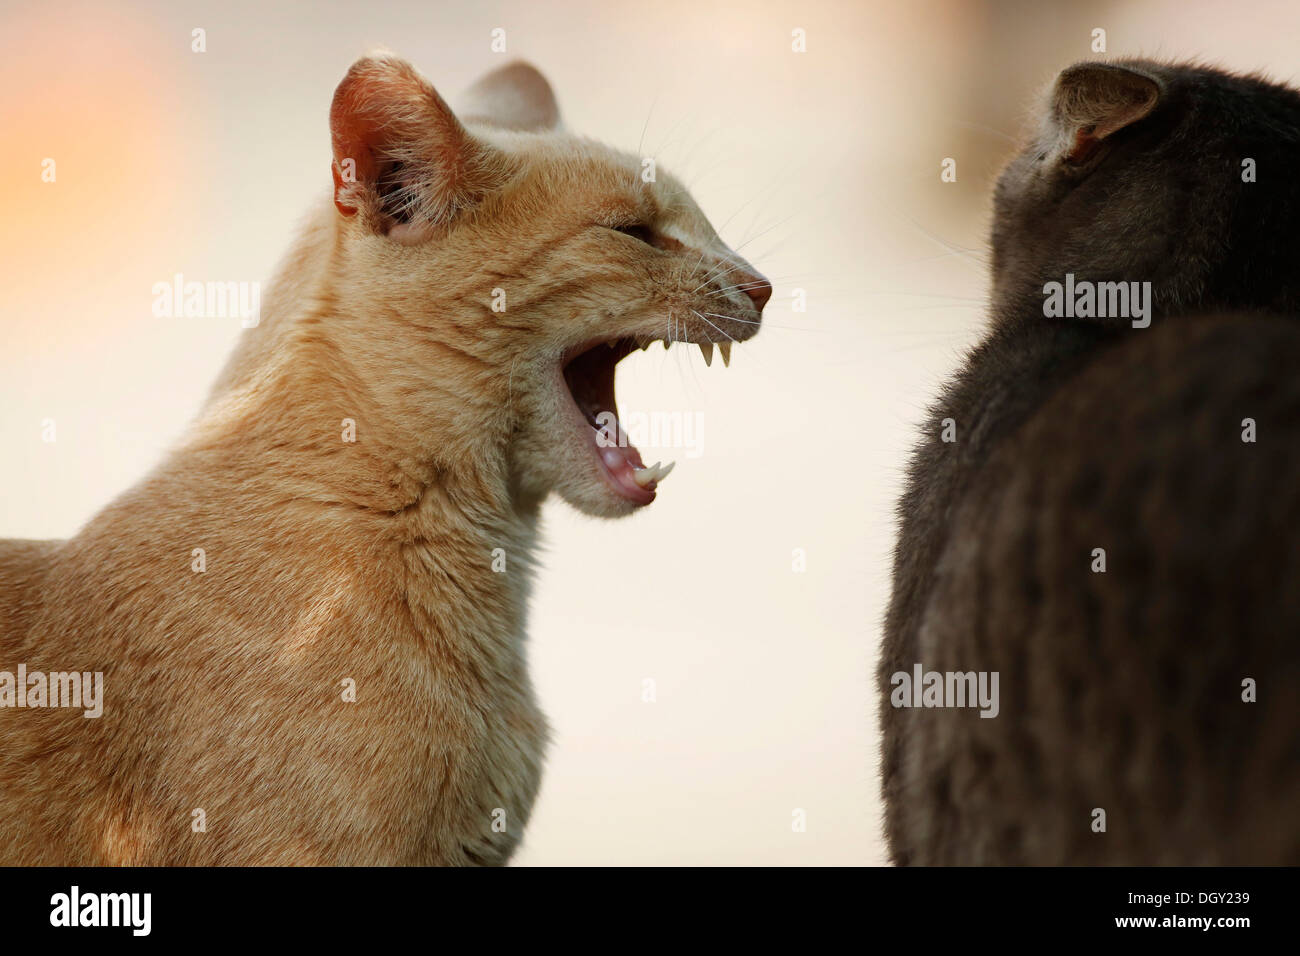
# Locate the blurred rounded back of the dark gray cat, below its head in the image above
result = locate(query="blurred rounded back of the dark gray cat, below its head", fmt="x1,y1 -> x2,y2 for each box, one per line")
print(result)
891,317 -> 1300,864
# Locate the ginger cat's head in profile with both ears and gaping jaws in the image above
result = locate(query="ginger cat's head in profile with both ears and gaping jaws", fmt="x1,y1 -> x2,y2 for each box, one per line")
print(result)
320,56 -> 771,516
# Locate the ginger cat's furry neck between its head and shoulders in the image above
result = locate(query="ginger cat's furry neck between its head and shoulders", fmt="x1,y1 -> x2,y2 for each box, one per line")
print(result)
178,200 -> 541,670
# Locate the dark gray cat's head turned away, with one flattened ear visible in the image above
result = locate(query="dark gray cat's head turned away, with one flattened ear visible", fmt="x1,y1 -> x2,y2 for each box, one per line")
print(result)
992,60 -> 1300,321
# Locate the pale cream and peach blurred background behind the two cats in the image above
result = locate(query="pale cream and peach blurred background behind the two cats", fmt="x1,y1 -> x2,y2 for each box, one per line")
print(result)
0,0 -> 1300,865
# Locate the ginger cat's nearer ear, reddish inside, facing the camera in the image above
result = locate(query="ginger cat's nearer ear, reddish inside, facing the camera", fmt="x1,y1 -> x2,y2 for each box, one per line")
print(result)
329,56 -> 511,242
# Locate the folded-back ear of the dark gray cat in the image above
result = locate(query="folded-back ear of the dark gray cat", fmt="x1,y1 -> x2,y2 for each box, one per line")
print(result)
1052,62 -> 1161,164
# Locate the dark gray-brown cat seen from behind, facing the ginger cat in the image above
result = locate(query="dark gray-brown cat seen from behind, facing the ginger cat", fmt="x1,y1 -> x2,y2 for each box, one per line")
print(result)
879,61 -> 1300,865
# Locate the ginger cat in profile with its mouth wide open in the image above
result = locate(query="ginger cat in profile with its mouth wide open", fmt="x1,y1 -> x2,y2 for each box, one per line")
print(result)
0,55 -> 771,865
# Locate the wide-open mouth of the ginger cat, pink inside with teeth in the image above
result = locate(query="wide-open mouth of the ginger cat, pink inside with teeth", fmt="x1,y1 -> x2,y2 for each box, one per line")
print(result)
562,338 -> 731,505
